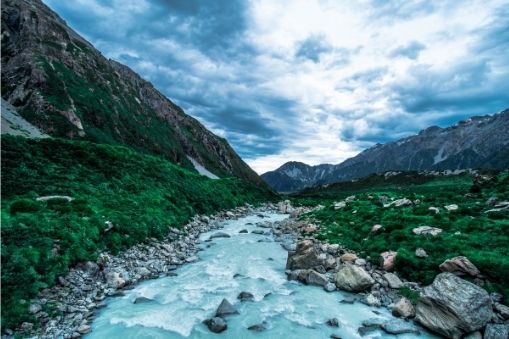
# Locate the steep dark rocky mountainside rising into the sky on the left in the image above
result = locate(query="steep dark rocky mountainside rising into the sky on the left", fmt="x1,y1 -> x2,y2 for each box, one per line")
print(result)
2,0 -> 265,185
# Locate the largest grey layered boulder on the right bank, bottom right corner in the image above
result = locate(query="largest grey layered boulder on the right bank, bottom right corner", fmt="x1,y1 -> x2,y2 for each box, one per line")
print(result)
416,273 -> 493,338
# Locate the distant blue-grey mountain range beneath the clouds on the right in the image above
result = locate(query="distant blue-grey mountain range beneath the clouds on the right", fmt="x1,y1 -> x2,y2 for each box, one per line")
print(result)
261,109 -> 509,192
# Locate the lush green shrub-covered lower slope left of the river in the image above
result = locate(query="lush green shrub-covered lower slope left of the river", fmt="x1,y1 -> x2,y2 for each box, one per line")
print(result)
1,135 -> 275,328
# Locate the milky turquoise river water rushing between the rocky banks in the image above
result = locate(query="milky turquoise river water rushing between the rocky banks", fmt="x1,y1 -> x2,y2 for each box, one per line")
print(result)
87,214 -> 433,339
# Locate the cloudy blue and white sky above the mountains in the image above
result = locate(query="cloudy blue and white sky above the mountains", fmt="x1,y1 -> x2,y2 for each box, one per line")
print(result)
44,0 -> 509,173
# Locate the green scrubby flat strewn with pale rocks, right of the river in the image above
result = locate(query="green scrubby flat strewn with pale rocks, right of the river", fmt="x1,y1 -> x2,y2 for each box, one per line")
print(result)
296,172 -> 509,300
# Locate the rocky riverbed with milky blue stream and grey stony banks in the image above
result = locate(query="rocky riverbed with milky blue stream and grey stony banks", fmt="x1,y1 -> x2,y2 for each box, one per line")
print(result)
5,202 -> 509,339
